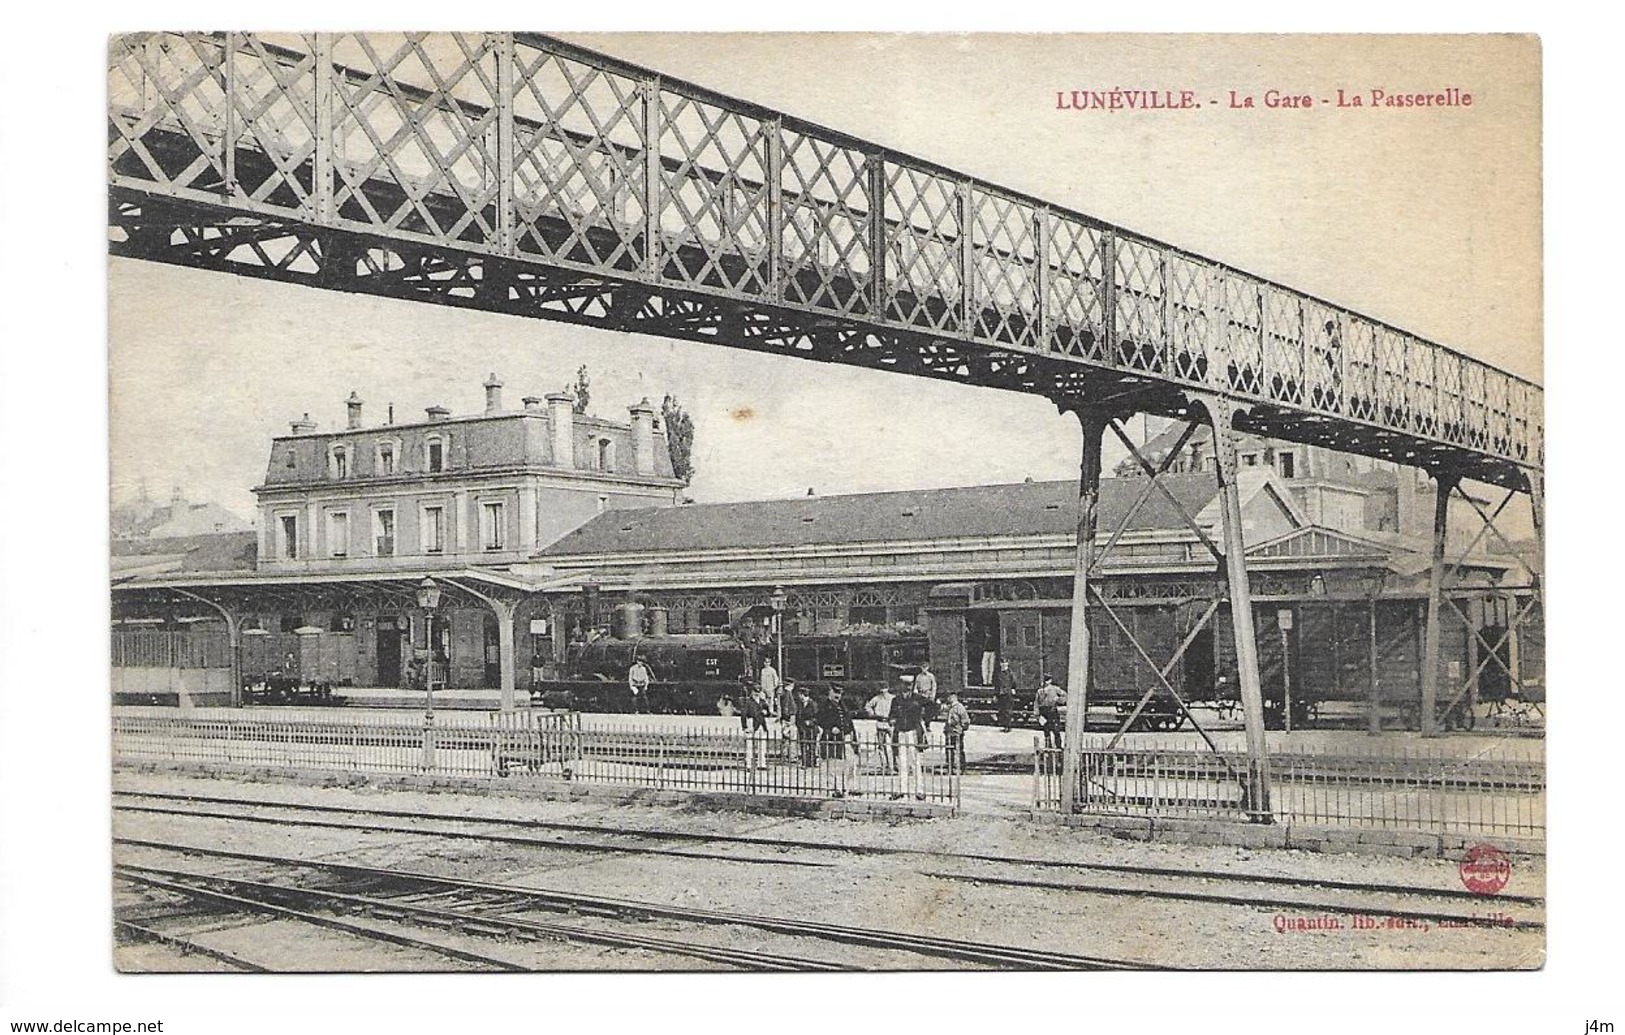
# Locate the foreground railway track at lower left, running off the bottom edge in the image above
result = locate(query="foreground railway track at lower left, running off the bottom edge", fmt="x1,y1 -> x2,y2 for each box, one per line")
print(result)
114,838 -> 1142,972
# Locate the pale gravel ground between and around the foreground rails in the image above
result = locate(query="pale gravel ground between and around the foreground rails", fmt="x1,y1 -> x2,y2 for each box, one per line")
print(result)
114,772 -> 1545,970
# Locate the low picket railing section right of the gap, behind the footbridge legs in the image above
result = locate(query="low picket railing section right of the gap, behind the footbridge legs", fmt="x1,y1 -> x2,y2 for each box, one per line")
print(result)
1034,741 -> 1545,837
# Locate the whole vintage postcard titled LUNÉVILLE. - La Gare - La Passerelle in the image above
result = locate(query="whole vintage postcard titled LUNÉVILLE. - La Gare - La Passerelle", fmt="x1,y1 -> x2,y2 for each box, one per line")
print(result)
106,31 -> 1547,973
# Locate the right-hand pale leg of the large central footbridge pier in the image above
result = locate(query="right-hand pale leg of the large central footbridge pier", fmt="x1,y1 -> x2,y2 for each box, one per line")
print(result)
1199,396 -> 1274,822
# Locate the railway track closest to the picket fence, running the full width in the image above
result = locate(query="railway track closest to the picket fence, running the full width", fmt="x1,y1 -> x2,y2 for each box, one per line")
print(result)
114,791 -> 1544,909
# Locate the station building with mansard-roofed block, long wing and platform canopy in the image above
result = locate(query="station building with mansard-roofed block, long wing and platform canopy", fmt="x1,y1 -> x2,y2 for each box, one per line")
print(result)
114,394 -> 1544,728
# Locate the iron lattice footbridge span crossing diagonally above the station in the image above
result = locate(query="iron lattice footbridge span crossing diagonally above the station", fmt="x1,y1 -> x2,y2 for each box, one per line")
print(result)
107,32 -> 1542,489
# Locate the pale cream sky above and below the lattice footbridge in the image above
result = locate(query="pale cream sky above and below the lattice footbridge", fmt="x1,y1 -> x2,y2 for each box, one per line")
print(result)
109,34 -> 1542,517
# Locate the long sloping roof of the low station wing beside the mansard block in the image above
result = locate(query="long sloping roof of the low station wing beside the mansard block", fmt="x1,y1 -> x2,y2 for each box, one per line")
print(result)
540,473 -> 1217,557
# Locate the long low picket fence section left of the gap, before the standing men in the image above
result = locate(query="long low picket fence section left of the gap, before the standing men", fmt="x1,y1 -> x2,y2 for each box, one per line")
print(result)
112,708 -> 960,808
